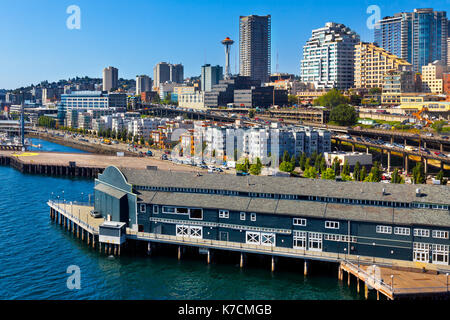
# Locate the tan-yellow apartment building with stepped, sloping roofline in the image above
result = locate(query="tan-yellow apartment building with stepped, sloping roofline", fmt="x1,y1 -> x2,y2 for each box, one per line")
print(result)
354,42 -> 412,88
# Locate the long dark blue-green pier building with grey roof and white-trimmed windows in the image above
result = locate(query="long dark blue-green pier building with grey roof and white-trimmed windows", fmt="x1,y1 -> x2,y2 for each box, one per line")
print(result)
95,167 -> 450,272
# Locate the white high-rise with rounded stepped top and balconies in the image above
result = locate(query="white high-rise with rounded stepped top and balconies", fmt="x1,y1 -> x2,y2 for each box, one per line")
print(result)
300,22 -> 359,90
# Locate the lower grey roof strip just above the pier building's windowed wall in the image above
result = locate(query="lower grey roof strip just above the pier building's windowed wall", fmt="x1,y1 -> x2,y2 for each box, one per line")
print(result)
138,191 -> 450,226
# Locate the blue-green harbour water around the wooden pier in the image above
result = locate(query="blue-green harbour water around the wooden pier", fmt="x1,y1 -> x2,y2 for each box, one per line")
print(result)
0,139 -> 360,300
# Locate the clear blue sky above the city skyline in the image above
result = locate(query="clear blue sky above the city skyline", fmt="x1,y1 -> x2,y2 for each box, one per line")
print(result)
0,0 -> 450,89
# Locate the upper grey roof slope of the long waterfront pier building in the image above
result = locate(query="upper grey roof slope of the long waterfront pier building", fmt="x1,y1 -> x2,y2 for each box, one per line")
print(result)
120,168 -> 450,205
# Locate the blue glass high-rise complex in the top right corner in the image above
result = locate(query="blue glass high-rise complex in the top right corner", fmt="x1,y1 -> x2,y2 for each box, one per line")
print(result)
374,8 -> 448,72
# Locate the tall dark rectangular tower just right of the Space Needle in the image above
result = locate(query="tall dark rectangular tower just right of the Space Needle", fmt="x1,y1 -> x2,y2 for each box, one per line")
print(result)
239,15 -> 271,82
